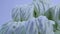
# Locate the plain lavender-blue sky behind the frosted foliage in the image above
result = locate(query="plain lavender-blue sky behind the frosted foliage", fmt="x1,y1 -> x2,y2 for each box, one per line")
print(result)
0,0 -> 60,25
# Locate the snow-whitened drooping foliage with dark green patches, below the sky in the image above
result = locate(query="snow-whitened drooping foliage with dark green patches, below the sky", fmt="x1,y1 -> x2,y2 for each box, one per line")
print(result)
0,0 -> 60,34
